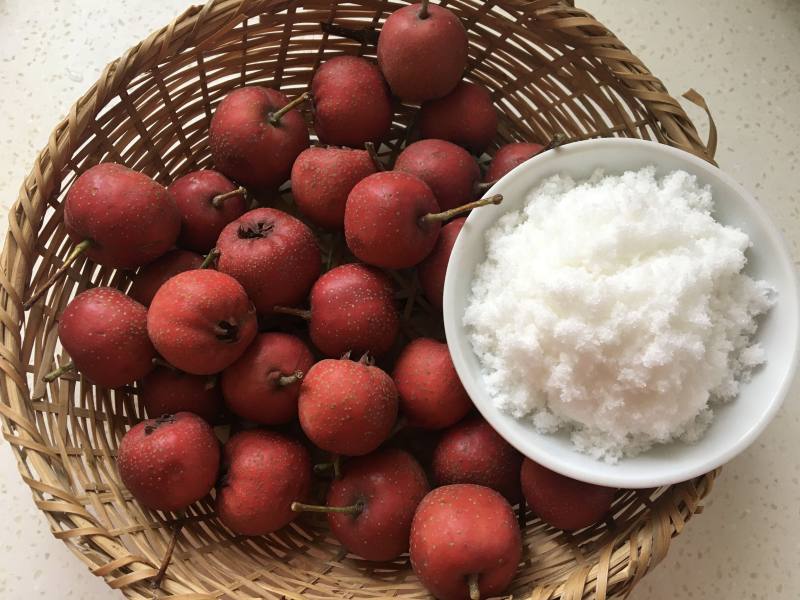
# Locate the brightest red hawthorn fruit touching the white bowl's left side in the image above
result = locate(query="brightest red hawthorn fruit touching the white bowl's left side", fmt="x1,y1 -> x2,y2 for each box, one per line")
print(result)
392,338 -> 472,429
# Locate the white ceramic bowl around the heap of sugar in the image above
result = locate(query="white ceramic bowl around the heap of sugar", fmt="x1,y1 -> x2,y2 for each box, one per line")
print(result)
444,138 -> 800,488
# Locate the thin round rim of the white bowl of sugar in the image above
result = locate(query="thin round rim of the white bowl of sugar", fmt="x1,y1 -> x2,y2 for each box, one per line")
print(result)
443,138 -> 800,489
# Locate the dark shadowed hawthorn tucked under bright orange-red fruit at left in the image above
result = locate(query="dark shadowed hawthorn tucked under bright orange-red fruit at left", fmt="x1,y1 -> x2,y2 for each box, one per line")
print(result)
140,367 -> 223,425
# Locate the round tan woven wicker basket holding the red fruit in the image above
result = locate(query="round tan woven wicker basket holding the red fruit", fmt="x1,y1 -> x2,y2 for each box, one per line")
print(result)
0,0 -> 716,600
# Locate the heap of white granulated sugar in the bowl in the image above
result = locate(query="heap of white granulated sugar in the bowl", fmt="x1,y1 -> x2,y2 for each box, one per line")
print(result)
464,167 -> 774,462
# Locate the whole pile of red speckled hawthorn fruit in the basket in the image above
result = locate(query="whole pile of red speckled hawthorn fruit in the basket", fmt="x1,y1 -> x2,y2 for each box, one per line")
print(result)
28,2 -> 616,600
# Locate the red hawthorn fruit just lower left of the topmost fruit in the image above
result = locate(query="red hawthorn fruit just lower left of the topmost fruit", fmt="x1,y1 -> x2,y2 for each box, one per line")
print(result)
310,55 -> 393,148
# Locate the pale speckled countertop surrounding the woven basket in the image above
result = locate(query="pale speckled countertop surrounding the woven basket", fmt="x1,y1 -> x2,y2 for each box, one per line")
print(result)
0,0 -> 800,600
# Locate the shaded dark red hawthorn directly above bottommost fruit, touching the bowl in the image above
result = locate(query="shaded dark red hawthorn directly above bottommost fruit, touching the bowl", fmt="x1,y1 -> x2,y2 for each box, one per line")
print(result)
433,417 -> 522,504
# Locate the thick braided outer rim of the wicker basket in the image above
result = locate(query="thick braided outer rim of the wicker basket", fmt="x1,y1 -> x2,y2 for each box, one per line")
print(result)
0,0 -> 718,600
